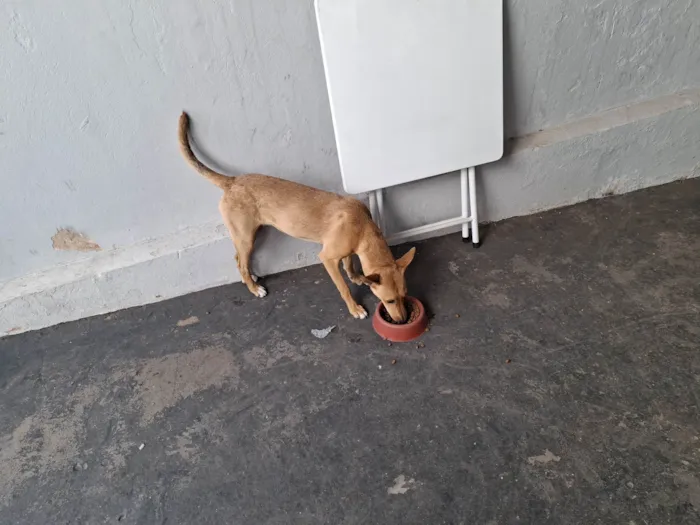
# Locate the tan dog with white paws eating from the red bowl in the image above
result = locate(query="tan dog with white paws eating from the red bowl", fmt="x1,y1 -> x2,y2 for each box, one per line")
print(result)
178,112 -> 416,323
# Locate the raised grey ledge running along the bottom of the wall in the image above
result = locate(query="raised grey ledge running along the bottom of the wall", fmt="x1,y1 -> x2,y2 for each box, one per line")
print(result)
0,90 -> 700,336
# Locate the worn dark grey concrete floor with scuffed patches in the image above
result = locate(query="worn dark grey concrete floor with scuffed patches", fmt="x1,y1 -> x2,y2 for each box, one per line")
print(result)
0,180 -> 700,525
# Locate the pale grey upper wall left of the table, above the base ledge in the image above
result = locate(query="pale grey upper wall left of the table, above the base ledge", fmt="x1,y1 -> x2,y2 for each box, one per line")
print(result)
0,0 -> 340,280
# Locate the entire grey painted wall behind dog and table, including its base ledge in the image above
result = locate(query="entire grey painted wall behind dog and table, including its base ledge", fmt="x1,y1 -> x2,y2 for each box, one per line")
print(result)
0,0 -> 700,334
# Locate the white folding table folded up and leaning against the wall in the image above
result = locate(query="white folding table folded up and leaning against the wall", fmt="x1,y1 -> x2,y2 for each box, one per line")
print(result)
316,0 -> 503,246
